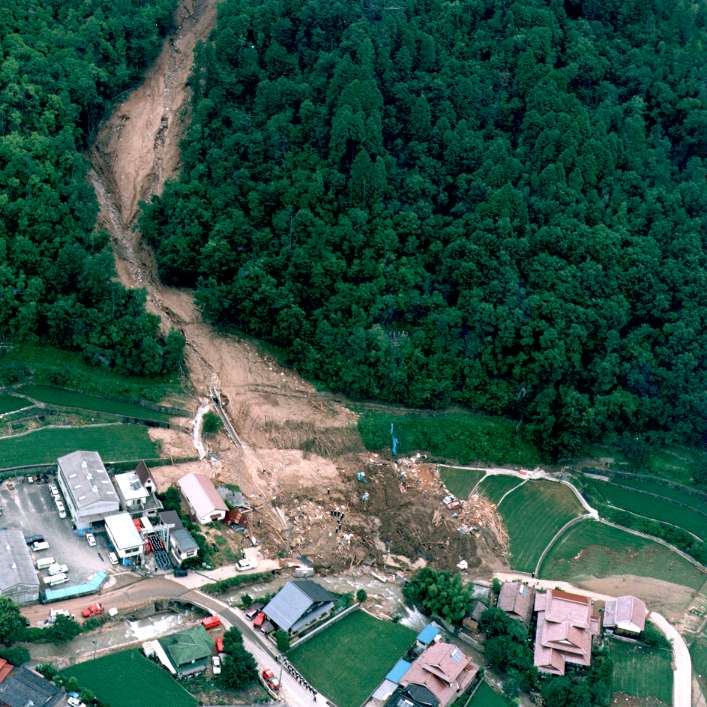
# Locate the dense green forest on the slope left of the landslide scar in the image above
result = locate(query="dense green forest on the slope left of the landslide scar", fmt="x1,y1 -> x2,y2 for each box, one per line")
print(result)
0,0 -> 183,375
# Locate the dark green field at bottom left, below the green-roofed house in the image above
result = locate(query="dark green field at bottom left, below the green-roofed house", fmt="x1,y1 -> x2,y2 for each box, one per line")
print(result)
62,650 -> 197,707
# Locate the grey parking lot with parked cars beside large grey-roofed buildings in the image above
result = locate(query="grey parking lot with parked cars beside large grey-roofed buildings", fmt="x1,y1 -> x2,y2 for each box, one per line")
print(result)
0,476 -> 111,584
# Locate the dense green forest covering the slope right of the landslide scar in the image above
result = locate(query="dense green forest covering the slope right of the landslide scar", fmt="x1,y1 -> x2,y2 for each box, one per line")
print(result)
142,0 -> 707,451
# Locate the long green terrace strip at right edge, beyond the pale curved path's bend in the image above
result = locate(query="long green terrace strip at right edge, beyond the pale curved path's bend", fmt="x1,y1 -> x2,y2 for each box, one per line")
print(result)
584,479 -> 707,539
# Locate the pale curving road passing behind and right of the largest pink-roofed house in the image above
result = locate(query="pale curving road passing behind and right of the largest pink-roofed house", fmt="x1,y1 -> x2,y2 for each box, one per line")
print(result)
494,572 -> 692,707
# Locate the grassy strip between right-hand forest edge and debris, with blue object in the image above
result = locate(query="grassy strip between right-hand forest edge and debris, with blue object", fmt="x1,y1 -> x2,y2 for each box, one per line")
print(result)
358,409 -> 540,466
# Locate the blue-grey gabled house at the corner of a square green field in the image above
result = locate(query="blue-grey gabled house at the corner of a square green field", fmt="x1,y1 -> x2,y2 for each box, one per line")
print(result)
263,579 -> 336,634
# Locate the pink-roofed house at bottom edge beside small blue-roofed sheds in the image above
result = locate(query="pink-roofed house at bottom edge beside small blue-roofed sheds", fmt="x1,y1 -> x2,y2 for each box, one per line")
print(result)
400,641 -> 479,707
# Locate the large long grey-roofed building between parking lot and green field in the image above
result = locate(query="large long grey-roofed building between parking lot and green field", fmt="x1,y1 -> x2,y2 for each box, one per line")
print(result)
57,451 -> 120,528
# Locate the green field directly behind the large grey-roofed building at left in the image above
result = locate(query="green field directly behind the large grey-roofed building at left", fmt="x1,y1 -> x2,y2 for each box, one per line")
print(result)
0,424 -> 159,468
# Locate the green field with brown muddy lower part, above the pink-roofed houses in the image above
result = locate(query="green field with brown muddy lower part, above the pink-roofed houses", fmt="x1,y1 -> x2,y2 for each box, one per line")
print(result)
540,520 -> 705,589
